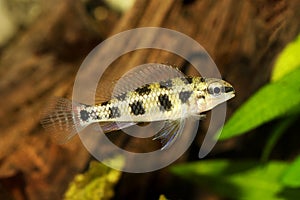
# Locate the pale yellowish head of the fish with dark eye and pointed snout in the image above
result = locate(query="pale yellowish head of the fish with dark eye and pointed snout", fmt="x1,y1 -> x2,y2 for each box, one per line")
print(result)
197,78 -> 235,112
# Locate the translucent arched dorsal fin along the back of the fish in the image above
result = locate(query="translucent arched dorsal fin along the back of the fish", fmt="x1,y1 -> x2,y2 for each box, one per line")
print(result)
112,63 -> 185,97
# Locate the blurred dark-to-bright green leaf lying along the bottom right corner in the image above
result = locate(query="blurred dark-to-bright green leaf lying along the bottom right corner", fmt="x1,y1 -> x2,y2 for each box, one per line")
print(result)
171,160 -> 300,200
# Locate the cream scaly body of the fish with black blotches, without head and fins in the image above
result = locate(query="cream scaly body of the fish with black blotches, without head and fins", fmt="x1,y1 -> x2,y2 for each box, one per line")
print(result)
78,77 -> 205,123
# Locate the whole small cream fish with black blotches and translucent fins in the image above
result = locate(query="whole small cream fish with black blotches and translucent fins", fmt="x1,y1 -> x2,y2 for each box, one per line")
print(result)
41,63 -> 235,150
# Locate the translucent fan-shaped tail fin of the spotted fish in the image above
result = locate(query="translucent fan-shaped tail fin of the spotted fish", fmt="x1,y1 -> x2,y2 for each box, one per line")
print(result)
40,98 -> 87,144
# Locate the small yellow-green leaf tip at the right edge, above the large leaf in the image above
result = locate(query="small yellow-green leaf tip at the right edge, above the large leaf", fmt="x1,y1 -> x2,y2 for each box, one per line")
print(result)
271,35 -> 300,81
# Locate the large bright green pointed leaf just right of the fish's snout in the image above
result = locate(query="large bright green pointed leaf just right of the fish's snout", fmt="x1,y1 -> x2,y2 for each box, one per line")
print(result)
219,68 -> 300,140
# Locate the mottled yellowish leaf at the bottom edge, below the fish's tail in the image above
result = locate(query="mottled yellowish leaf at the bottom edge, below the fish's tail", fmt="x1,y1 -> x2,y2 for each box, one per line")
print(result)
64,158 -> 122,200
